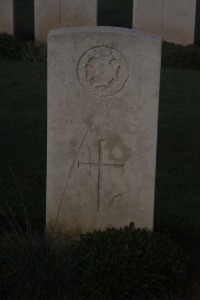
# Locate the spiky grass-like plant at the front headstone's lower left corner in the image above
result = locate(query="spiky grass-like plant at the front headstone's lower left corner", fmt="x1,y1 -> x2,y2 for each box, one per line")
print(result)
0,232 -> 76,300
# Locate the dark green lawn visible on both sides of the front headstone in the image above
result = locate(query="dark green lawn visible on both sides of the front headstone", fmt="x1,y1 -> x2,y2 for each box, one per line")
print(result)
0,61 -> 200,242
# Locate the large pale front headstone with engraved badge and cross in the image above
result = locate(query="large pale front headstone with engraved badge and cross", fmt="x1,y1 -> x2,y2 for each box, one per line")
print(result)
47,27 -> 161,234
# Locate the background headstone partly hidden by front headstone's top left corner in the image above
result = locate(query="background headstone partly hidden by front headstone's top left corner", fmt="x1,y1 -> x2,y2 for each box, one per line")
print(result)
34,0 -> 97,41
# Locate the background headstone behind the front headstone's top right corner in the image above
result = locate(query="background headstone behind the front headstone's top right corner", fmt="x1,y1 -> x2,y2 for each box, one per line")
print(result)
133,0 -> 196,45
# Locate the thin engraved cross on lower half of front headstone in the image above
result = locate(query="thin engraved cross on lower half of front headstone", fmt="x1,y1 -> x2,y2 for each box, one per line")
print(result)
78,140 -> 124,212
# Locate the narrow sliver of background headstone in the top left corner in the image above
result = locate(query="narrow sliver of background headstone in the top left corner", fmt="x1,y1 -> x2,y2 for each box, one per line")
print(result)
0,0 -> 14,34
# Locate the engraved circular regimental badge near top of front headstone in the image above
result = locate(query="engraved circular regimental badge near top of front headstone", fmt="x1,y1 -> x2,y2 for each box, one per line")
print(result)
77,46 -> 129,97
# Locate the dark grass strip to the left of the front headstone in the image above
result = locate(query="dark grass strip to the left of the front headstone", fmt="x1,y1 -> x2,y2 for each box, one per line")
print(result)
0,61 -> 46,230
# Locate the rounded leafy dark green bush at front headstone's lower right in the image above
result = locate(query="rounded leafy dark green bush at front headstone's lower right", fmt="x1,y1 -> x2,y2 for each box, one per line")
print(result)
78,224 -> 186,300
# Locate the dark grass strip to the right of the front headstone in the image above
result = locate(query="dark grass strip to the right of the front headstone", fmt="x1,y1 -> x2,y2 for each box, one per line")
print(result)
155,70 -> 200,240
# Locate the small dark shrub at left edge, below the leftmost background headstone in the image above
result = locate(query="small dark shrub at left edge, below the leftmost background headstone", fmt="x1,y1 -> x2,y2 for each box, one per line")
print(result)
0,32 -> 21,60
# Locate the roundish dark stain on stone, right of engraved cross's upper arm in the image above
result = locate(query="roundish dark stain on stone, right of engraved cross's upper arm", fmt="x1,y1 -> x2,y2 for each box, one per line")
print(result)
106,134 -> 132,163
